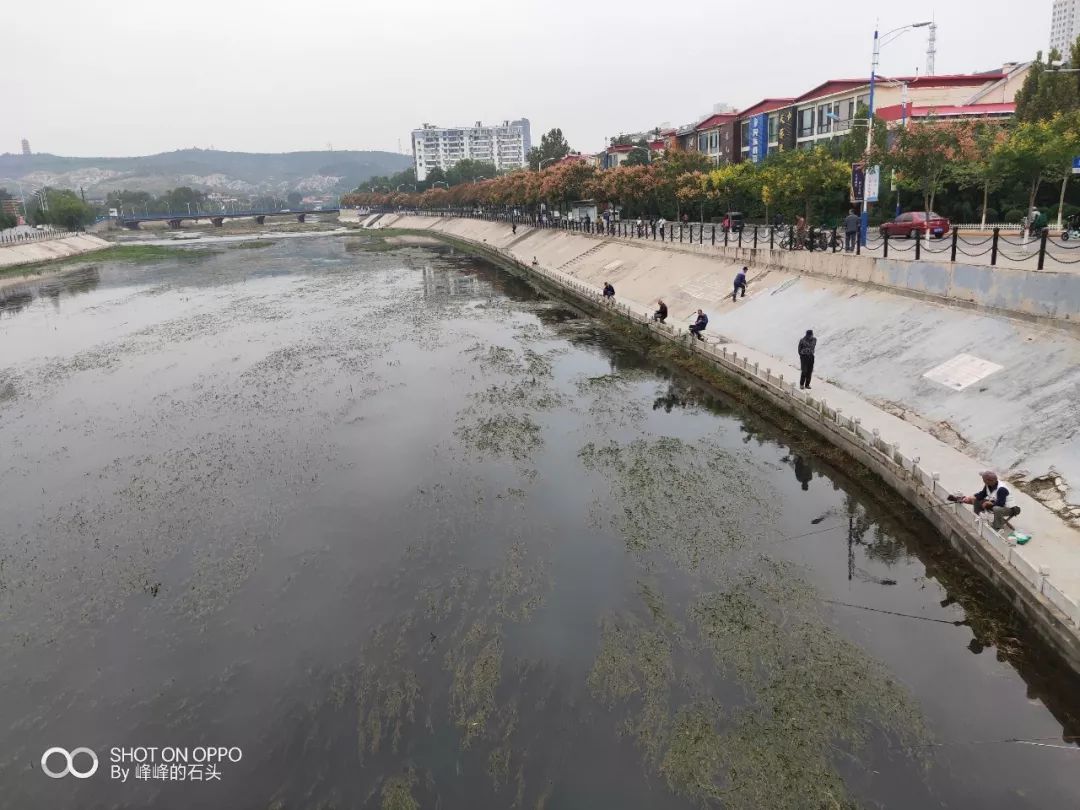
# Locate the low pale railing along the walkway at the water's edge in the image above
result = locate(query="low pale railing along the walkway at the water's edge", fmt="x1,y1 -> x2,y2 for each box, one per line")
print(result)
483,240 -> 1080,627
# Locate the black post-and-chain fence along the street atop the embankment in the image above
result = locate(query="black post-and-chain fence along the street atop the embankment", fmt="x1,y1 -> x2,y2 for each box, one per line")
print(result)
401,210 -> 1080,270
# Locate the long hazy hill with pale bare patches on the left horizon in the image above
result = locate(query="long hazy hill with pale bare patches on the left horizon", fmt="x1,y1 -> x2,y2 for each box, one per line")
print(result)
0,149 -> 411,198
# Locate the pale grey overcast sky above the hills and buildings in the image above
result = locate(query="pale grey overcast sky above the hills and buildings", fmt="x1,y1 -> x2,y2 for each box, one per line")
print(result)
8,0 -> 1051,156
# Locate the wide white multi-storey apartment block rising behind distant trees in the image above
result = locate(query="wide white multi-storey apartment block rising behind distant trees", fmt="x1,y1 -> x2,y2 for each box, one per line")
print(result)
413,118 -> 532,183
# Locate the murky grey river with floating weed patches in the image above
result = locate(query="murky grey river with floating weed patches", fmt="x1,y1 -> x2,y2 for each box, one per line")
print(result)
0,237 -> 1080,810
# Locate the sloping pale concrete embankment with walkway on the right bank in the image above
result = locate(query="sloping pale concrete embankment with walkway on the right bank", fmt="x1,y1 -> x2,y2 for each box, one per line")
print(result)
380,212 -> 1080,672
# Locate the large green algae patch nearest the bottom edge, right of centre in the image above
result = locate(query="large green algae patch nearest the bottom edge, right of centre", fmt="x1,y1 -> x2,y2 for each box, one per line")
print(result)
588,558 -> 928,810
